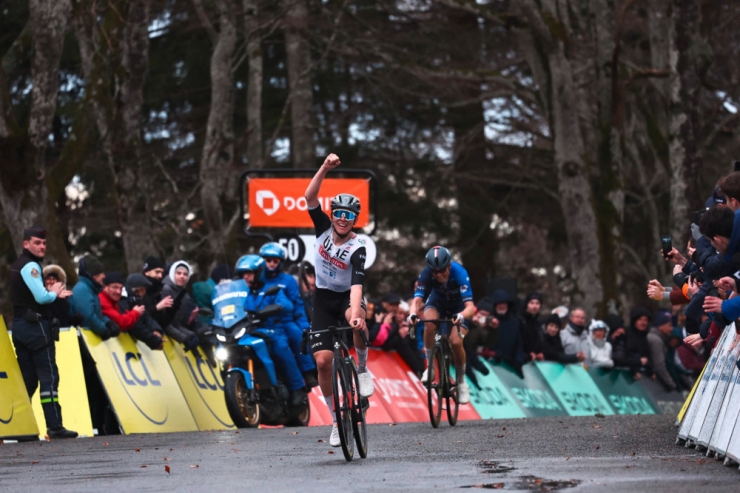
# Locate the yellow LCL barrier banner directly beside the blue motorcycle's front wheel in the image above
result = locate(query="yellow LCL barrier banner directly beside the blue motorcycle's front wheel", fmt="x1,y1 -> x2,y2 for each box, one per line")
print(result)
164,341 -> 236,431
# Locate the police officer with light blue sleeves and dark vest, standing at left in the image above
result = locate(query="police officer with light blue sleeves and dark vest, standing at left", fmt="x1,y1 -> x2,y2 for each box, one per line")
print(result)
10,227 -> 77,438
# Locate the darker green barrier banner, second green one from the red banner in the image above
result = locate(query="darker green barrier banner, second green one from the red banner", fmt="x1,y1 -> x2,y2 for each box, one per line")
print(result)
491,363 -> 568,418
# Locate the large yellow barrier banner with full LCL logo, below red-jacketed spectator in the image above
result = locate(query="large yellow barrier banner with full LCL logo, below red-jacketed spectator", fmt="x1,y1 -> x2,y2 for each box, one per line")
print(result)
82,329 -> 198,434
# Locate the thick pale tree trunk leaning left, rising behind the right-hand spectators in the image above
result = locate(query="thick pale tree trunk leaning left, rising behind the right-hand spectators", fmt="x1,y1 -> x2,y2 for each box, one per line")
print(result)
519,0 -> 605,313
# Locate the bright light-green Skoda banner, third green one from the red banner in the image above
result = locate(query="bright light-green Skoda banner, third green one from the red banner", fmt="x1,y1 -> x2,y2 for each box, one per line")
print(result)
535,361 -> 614,416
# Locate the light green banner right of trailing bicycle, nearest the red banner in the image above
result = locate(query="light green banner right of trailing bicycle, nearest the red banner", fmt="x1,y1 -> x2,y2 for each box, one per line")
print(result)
467,360 -> 527,419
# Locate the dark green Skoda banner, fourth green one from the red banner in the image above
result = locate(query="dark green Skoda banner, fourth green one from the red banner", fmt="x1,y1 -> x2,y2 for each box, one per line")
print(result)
588,368 -> 660,414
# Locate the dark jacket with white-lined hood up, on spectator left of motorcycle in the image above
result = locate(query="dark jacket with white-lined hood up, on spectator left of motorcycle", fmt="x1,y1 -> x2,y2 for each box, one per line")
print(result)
162,260 -> 201,347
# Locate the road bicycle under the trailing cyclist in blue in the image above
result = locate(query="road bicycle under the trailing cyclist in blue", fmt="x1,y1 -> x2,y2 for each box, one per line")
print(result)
416,319 -> 460,428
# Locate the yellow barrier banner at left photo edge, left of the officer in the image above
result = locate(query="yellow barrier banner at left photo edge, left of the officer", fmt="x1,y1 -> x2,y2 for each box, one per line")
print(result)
0,317 -> 39,438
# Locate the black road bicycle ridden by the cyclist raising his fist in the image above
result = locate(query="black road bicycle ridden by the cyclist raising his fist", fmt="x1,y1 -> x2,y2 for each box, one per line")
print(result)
303,327 -> 370,462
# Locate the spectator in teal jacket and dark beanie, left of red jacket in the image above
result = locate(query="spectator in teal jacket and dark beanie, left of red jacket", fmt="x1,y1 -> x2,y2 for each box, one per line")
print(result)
72,255 -> 121,341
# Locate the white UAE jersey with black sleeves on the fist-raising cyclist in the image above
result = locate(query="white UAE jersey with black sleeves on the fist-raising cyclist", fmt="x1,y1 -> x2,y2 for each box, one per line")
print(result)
308,204 -> 366,293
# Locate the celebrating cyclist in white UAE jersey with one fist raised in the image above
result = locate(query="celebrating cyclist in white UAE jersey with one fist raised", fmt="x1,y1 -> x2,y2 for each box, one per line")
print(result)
306,154 -> 374,447
